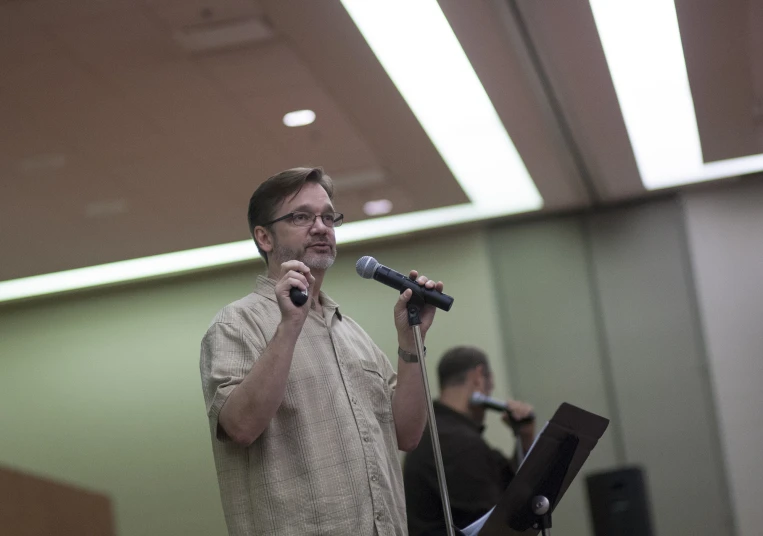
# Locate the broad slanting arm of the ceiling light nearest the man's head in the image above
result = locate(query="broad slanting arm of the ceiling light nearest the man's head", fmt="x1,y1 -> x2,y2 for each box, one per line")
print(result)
342,0 -> 543,214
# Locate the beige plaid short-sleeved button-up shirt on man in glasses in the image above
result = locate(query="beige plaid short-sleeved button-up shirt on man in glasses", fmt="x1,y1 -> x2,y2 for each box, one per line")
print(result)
200,276 -> 407,536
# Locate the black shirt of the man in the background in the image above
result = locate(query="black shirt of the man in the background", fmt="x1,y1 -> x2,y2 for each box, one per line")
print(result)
403,401 -> 514,536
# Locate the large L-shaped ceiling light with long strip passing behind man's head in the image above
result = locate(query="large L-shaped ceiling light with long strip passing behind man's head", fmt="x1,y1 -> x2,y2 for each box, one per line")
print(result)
0,0 -> 543,302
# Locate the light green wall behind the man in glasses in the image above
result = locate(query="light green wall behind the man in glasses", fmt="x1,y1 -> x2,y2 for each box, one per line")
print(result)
0,231 -> 510,536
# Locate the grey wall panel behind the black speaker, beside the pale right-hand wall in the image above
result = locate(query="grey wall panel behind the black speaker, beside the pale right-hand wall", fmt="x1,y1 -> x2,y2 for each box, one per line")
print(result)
587,199 -> 733,536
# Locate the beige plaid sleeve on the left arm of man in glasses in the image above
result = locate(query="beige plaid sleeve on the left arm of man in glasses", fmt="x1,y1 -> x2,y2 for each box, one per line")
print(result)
199,322 -> 263,441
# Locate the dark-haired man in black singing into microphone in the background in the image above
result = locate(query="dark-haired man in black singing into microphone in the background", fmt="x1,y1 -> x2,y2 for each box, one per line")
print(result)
403,346 -> 535,536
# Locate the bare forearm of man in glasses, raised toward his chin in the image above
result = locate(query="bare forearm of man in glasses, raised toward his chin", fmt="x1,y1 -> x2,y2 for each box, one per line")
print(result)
219,324 -> 300,445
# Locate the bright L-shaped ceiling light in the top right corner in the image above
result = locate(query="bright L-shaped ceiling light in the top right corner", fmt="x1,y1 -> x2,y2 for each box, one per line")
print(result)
590,0 -> 763,190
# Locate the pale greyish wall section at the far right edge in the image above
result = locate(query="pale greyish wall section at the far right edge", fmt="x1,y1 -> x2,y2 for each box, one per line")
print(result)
685,182 -> 763,536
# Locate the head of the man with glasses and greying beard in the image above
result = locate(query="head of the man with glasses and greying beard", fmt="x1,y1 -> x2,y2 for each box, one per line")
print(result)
247,167 -> 336,270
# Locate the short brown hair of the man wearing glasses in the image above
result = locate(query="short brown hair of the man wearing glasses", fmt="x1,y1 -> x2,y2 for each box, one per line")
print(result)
247,167 -> 334,264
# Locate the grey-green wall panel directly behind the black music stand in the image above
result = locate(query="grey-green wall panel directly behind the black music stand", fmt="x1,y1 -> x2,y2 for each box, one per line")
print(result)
490,217 -> 620,536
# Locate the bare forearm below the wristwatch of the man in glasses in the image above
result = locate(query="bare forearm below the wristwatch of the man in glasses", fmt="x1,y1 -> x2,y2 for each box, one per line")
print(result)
392,359 -> 427,452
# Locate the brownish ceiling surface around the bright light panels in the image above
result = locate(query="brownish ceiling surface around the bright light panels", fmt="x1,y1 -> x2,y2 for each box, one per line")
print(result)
0,0 -> 763,281
